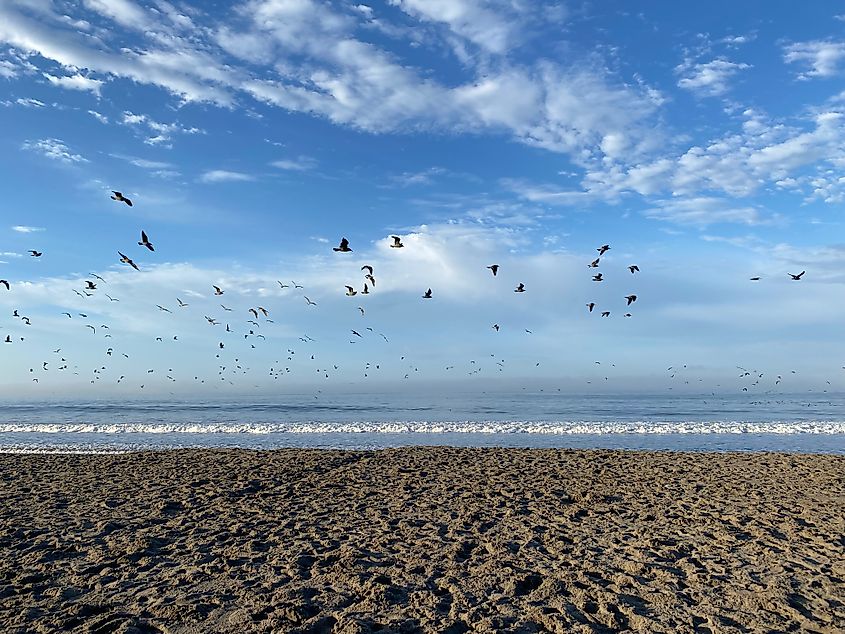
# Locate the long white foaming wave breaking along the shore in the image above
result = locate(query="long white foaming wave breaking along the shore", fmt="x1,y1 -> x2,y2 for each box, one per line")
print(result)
0,420 -> 845,435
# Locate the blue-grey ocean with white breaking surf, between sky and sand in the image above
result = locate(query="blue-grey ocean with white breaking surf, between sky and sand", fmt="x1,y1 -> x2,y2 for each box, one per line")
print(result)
0,391 -> 845,454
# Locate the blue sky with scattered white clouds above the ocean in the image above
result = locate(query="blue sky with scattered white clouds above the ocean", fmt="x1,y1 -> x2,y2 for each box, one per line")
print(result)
0,0 -> 845,396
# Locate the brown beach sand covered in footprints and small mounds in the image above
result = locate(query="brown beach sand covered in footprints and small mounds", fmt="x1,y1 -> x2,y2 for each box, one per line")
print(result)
0,448 -> 845,634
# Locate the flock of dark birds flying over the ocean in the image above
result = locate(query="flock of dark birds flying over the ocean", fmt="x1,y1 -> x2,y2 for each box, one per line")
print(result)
0,191 -> 832,391
